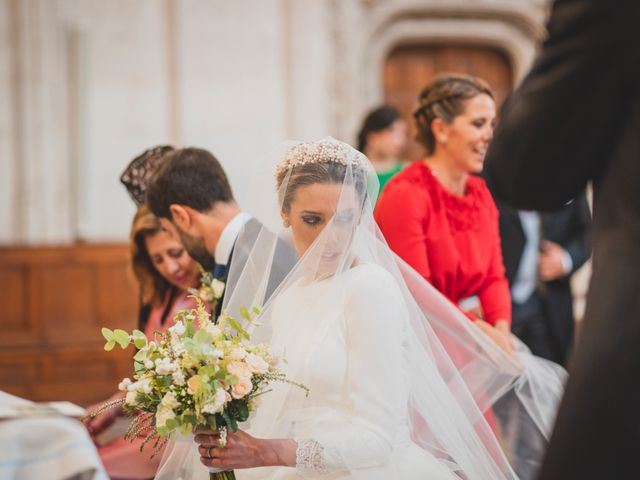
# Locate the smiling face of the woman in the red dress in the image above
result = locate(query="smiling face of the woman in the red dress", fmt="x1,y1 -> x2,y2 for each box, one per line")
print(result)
436,94 -> 496,173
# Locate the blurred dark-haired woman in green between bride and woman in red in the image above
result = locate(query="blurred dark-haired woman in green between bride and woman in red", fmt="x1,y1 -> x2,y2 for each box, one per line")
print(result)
358,105 -> 407,195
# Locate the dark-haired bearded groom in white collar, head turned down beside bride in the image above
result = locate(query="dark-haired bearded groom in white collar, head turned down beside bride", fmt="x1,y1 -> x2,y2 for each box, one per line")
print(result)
146,148 -> 296,318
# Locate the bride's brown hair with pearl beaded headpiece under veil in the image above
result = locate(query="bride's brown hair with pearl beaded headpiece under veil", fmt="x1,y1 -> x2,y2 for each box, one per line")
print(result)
276,137 -> 369,212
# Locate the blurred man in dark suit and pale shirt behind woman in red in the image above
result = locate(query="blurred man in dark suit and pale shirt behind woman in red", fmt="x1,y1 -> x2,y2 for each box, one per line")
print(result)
497,194 -> 591,365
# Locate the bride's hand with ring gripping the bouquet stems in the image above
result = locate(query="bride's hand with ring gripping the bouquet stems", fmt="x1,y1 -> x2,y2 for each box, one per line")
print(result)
195,430 -> 298,470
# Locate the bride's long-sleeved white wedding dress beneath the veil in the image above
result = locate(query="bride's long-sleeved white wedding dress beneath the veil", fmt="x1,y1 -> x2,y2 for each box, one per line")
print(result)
245,264 -> 459,480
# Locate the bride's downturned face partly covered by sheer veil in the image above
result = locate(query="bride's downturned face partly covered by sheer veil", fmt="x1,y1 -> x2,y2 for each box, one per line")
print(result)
282,183 -> 357,273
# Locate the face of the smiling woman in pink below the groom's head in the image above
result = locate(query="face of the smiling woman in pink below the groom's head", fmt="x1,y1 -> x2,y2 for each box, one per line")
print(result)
145,226 -> 200,290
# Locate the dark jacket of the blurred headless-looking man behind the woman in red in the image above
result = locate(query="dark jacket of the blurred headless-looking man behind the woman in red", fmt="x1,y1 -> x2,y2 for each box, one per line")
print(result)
497,193 -> 591,364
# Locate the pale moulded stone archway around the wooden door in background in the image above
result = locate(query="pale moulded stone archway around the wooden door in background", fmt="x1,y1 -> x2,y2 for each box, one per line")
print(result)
336,0 -> 549,141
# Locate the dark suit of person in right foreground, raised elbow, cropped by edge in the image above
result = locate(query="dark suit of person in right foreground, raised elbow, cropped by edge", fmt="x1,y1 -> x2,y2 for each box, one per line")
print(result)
486,0 -> 640,480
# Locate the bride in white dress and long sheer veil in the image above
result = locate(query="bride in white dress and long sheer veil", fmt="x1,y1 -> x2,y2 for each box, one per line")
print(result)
156,138 -> 561,479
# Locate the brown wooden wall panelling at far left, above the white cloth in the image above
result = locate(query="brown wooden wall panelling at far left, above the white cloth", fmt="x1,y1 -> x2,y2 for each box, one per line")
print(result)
0,245 -> 138,406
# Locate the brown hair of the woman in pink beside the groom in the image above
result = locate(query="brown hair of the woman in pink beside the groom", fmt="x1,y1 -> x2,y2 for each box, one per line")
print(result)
130,204 -> 171,306
